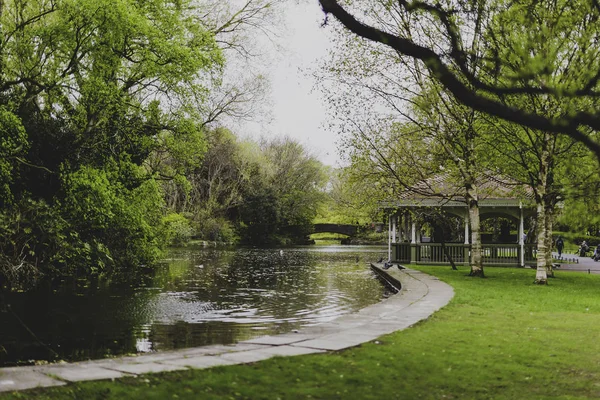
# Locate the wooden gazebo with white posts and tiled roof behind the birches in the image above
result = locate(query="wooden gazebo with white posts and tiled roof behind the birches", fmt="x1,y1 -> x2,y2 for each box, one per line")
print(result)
382,176 -> 536,266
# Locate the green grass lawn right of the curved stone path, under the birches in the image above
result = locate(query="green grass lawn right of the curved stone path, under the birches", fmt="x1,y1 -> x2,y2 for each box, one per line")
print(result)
0,267 -> 600,400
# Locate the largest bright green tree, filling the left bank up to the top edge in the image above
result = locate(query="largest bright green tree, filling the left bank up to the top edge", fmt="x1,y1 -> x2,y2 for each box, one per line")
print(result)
0,0 -> 223,282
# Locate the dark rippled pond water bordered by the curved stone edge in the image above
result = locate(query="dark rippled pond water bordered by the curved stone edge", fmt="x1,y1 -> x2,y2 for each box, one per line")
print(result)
0,245 -> 387,366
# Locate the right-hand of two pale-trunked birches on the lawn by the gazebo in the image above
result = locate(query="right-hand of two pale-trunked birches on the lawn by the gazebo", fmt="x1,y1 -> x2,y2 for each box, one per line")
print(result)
474,2 -> 597,284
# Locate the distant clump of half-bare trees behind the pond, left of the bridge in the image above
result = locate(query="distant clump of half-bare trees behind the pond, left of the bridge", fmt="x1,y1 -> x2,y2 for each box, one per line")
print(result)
166,128 -> 327,245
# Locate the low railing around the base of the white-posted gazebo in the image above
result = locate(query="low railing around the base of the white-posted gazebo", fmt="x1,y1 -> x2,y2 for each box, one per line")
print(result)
392,243 -> 537,266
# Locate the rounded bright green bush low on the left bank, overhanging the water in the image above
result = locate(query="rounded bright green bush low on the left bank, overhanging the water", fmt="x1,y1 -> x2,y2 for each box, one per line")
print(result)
61,164 -> 165,272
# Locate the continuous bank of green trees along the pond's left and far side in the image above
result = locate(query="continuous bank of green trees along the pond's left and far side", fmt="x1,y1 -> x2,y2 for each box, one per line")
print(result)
0,0 -> 324,287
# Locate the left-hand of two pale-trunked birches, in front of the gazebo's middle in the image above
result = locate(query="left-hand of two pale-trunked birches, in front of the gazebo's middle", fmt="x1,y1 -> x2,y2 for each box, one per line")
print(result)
316,3 -> 490,276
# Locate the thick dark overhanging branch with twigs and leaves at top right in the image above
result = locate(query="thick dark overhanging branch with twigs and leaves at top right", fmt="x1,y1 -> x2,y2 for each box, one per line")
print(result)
319,0 -> 600,162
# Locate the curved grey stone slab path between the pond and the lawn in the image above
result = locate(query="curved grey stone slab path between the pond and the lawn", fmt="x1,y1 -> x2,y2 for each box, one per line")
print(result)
0,265 -> 454,392
